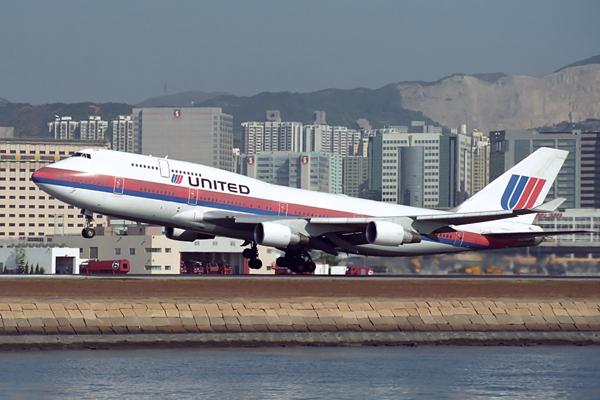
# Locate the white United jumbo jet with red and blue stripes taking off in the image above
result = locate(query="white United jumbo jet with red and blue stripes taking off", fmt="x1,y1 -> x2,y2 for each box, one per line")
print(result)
32,148 -> 582,272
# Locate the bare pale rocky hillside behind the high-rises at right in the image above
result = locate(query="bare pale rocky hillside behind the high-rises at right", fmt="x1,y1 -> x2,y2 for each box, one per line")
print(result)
395,64 -> 600,132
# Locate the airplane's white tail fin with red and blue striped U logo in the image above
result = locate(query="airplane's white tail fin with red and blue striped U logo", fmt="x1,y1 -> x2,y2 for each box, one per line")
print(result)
455,147 -> 569,224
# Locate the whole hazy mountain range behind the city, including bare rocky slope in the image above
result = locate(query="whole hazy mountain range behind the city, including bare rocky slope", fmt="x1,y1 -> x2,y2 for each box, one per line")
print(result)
0,56 -> 600,139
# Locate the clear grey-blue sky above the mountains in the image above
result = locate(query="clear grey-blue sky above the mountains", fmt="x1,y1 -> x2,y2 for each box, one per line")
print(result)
0,0 -> 600,104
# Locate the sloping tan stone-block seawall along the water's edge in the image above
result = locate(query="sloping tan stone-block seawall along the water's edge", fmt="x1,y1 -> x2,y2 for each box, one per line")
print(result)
0,293 -> 600,350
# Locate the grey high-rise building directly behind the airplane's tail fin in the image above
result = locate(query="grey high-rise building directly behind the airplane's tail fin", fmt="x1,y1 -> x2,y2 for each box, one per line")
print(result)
489,130 -> 581,210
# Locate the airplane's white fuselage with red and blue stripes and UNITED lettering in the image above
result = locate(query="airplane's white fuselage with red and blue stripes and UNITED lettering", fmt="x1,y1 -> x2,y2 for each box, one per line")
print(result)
33,149 -> 540,256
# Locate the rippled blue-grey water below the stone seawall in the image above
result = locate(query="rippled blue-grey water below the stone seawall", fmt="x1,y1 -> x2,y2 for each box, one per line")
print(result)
0,346 -> 600,399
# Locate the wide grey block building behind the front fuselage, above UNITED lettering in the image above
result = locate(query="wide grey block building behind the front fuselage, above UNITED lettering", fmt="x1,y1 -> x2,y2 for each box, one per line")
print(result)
133,107 -> 235,171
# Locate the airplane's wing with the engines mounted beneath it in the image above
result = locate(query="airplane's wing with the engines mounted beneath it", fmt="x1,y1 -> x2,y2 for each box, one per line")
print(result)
202,199 -> 571,254
